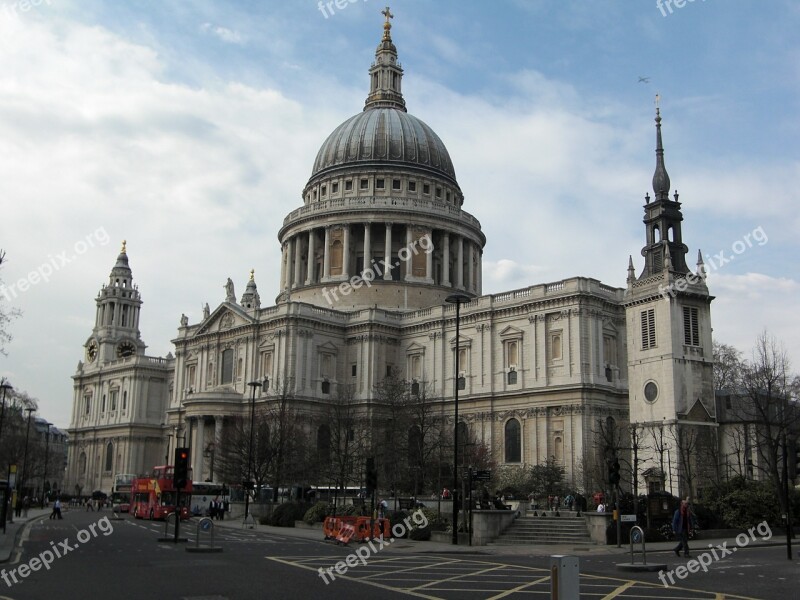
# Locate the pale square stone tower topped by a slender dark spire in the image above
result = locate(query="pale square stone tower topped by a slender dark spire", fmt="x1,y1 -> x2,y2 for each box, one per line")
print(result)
624,103 -> 716,496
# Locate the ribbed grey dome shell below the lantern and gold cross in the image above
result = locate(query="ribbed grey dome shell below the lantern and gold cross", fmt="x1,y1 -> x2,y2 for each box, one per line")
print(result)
311,106 -> 457,184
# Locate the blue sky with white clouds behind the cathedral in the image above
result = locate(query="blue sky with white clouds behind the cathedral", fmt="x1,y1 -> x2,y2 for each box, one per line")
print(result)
0,0 -> 800,428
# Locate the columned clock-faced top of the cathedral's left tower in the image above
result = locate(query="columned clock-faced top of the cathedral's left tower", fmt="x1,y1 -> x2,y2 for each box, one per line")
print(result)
84,241 -> 146,366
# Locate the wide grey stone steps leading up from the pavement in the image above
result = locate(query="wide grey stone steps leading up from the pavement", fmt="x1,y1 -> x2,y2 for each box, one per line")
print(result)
493,511 -> 593,545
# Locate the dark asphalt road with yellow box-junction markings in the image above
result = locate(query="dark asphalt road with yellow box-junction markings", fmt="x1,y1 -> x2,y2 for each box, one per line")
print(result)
0,511 -> 800,600
